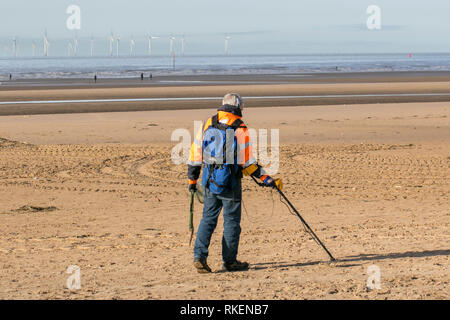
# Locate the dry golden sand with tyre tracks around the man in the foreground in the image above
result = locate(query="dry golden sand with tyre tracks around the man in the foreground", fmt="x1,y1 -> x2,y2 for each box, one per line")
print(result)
0,85 -> 450,299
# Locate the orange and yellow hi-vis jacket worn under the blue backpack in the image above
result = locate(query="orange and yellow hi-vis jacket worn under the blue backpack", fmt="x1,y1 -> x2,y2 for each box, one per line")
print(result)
188,105 -> 267,184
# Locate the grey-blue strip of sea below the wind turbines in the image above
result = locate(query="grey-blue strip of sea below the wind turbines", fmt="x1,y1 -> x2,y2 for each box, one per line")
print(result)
0,53 -> 450,80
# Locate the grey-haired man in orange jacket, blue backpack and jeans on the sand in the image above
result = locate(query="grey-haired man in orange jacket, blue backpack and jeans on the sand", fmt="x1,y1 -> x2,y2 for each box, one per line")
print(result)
188,93 -> 282,273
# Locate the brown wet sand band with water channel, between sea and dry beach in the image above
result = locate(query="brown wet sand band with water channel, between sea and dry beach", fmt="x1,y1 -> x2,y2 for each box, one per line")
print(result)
0,71 -> 450,116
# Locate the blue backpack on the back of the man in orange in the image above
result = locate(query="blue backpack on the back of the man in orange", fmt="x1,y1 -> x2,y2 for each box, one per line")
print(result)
202,115 -> 243,194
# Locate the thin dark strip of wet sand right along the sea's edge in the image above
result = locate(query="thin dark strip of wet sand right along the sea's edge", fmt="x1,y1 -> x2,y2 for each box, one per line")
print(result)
4,71 -> 450,90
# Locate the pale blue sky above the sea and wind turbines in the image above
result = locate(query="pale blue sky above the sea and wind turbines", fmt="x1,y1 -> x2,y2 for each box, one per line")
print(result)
0,0 -> 450,54
